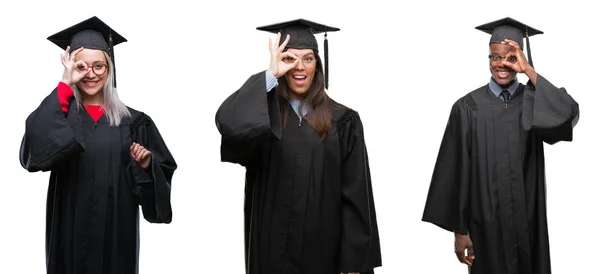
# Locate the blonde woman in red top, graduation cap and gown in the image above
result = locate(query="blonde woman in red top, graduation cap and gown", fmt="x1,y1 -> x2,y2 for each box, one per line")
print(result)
20,17 -> 177,274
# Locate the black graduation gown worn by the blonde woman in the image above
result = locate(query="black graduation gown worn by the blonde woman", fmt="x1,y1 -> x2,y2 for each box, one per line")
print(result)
20,89 -> 177,274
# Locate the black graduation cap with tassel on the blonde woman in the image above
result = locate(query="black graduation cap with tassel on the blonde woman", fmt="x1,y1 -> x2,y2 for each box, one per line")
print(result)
48,16 -> 127,87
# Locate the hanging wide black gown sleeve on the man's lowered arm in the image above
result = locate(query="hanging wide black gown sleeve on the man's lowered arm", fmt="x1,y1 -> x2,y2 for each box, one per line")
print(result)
422,98 -> 474,235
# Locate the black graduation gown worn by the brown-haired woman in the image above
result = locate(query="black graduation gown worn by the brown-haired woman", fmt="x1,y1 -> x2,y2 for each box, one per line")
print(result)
216,72 -> 381,274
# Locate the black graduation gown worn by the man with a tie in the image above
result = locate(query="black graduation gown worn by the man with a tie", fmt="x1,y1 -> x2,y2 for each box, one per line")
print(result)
422,75 -> 579,274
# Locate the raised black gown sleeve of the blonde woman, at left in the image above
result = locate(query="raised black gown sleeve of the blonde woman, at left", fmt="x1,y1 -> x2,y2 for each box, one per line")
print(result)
19,89 -> 85,172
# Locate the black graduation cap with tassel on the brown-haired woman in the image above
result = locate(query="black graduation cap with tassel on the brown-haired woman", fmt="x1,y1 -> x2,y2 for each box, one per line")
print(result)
256,19 -> 340,88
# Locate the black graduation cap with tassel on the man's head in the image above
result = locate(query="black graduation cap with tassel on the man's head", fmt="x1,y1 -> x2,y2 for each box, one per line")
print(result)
475,17 -> 544,67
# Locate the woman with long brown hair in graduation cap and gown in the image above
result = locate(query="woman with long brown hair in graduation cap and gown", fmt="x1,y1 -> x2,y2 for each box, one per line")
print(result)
216,19 -> 381,274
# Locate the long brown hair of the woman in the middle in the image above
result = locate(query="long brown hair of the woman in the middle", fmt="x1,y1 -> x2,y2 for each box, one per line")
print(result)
277,54 -> 332,140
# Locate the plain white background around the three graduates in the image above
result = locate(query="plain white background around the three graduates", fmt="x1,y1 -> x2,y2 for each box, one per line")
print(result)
0,0 -> 600,274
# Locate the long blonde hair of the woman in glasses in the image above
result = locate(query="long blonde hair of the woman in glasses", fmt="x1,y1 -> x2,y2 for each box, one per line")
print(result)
71,52 -> 131,127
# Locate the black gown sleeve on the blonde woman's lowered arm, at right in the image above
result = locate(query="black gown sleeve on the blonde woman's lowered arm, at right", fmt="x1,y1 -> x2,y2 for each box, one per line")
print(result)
128,112 -> 177,224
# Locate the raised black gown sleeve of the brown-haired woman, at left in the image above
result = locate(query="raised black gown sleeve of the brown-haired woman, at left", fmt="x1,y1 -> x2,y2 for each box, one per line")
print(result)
215,72 -> 282,166
